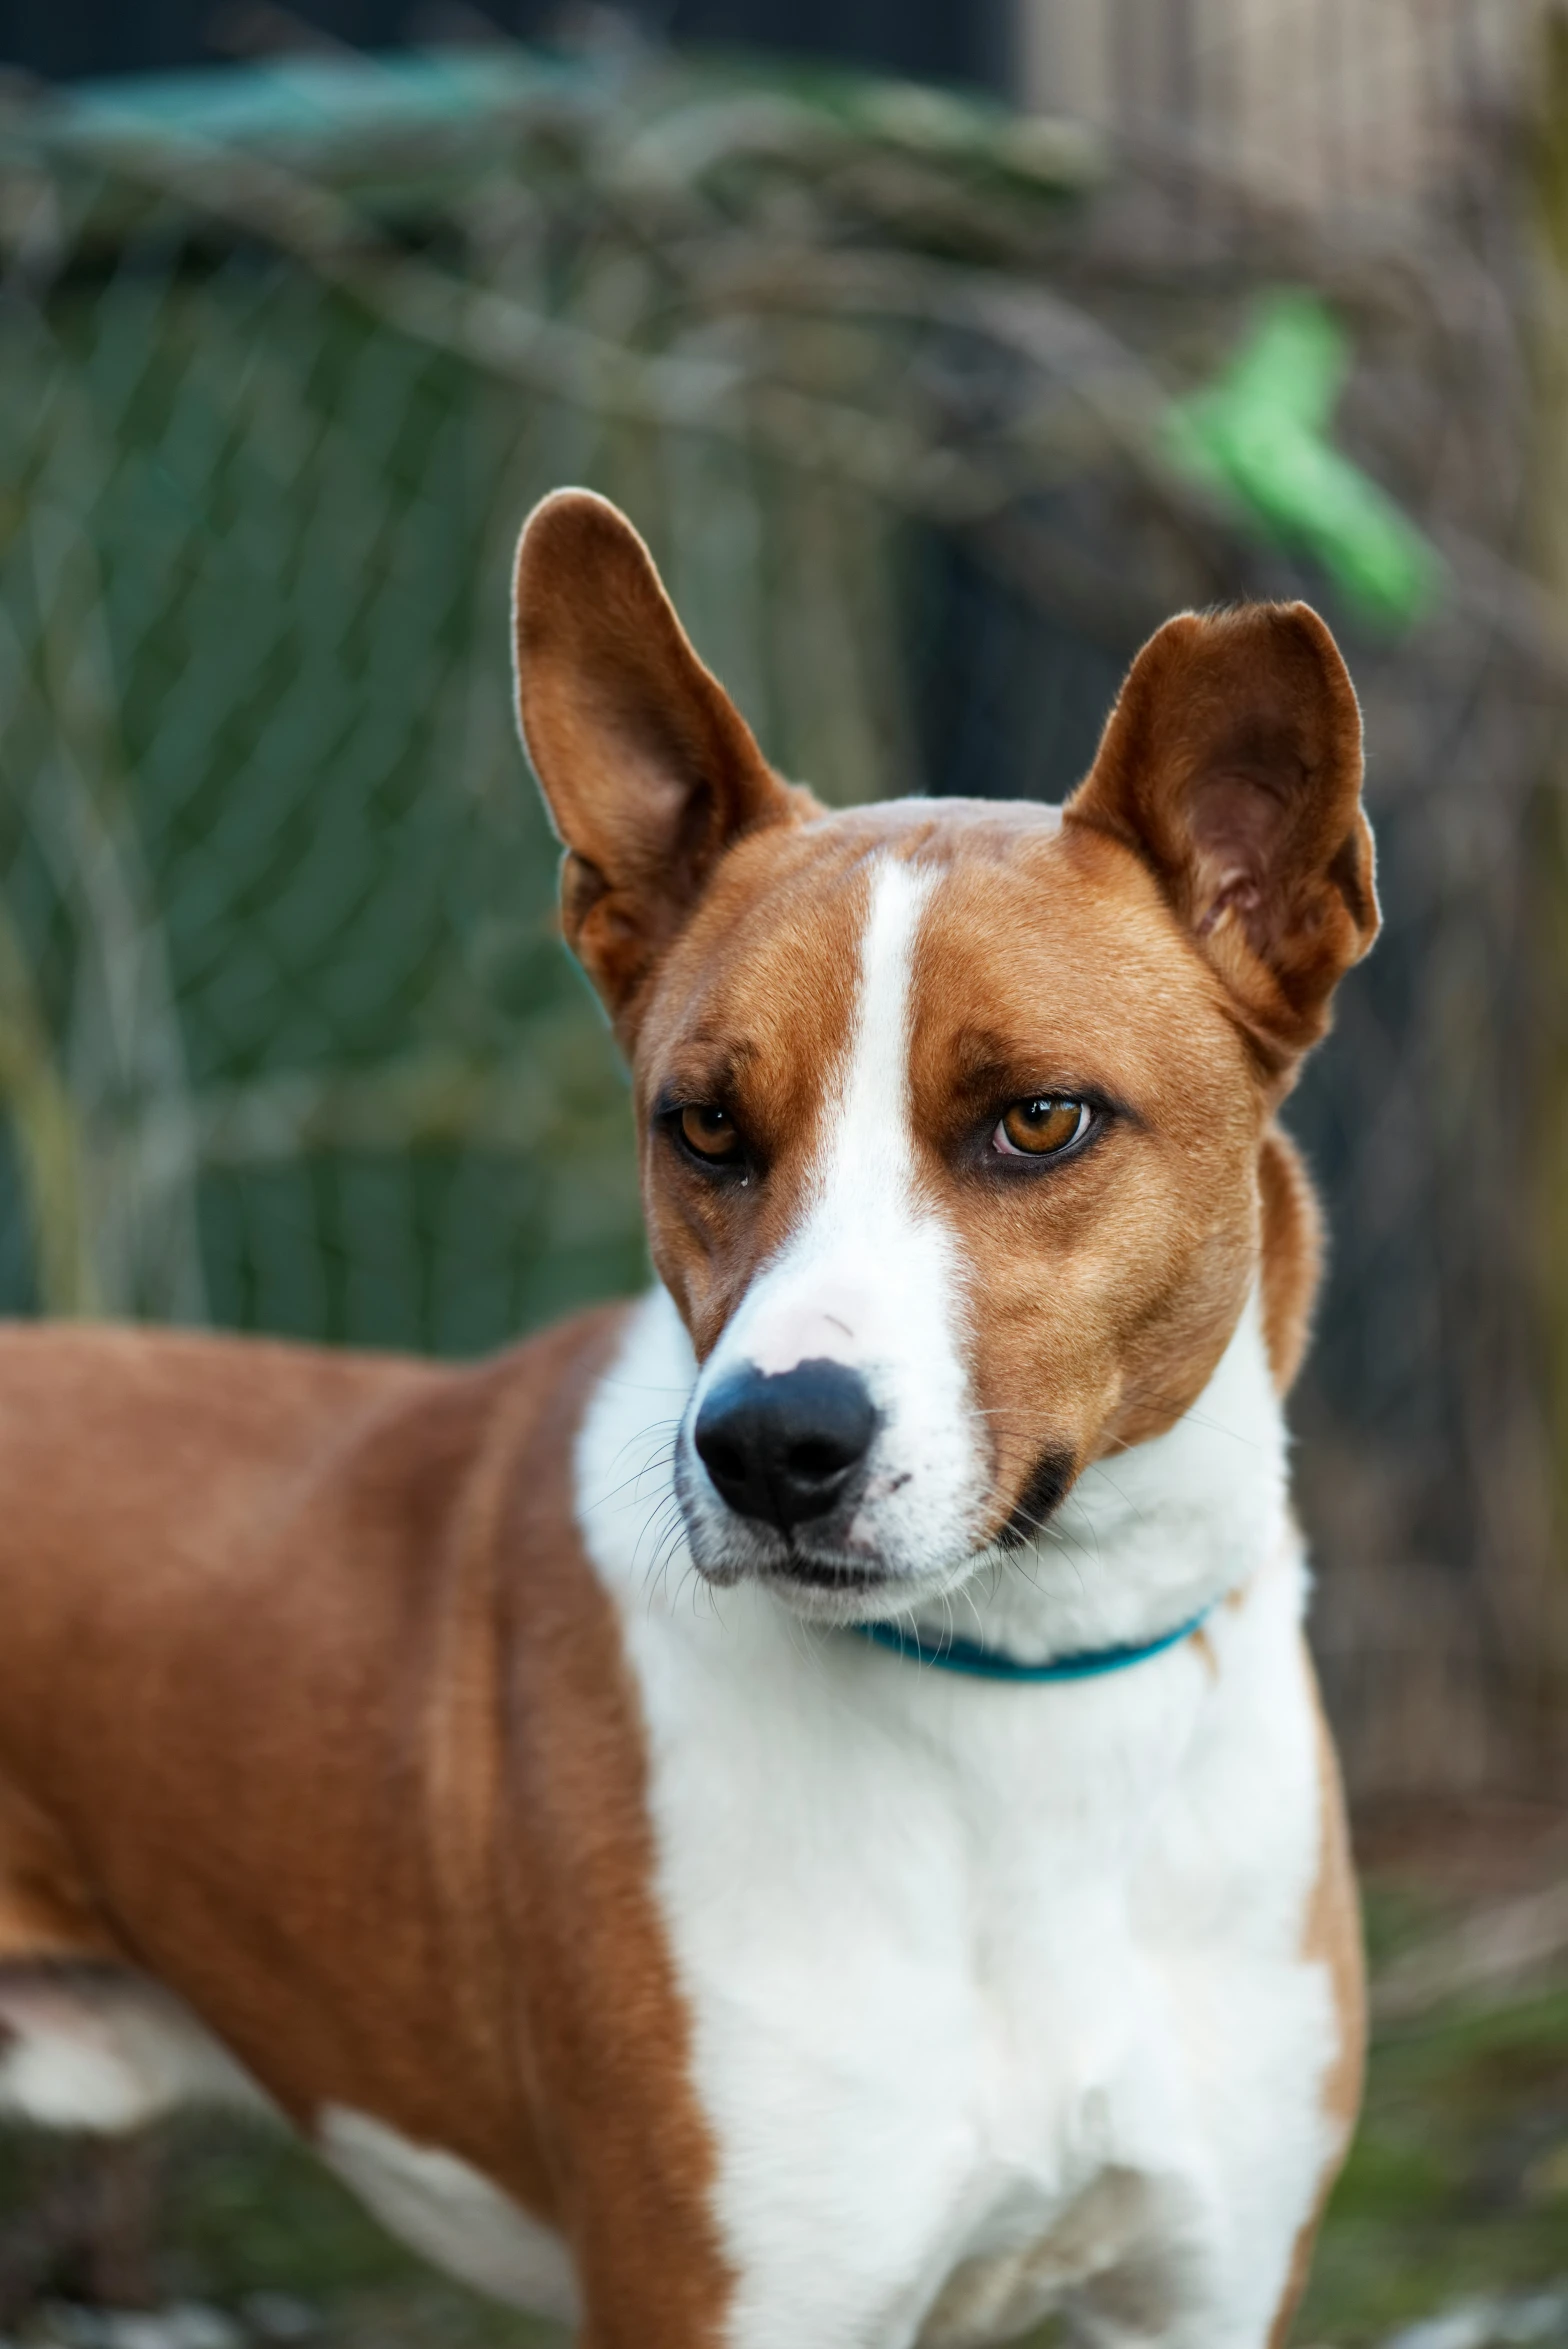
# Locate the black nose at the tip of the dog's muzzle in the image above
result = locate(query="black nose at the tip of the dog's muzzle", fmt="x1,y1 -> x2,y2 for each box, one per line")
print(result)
692,1360 -> 878,1534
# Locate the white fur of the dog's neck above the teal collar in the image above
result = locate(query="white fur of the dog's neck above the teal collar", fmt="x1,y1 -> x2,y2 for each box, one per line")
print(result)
577,1290 -> 1289,1663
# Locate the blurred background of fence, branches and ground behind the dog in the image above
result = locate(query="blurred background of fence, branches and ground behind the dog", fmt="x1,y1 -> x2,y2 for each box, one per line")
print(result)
0,0 -> 1568,2349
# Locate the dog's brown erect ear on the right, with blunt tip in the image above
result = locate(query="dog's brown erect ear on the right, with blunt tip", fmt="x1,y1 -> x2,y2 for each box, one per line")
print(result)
1063,604 -> 1378,1069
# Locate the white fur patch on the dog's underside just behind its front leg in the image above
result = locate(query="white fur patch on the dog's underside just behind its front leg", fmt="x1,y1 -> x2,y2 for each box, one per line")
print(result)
317,2105 -> 577,2323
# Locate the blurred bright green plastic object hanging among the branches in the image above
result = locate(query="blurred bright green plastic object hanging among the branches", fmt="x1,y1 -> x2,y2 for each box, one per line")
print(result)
1164,291 -> 1441,627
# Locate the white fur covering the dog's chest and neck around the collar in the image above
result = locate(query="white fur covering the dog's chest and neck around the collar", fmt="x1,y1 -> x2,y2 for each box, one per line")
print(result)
577,1294 -> 1336,2349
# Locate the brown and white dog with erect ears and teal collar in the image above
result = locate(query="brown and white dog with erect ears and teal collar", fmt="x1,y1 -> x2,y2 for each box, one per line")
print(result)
0,493 -> 1378,2349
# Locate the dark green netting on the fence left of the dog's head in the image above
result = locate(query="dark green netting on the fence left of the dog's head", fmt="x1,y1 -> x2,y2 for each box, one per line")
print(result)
0,251 -> 638,1348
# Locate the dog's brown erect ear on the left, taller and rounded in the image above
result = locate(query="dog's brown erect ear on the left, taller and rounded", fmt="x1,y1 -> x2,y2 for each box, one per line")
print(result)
512,489 -> 803,1024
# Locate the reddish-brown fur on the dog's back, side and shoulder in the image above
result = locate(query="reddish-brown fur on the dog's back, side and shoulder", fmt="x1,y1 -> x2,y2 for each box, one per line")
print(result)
0,1313 -> 728,2349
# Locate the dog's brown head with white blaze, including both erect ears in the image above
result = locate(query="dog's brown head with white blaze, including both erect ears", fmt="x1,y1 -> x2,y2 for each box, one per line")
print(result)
516,491 -> 1378,1621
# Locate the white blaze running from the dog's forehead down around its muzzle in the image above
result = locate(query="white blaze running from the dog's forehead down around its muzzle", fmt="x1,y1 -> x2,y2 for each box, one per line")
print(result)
702,857 -> 984,1567
